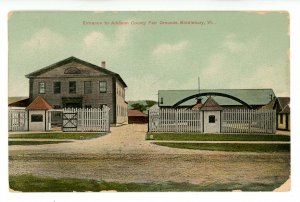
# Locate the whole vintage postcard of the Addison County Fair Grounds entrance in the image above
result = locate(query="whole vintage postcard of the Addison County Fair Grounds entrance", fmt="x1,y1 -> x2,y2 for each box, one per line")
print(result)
8,11 -> 291,192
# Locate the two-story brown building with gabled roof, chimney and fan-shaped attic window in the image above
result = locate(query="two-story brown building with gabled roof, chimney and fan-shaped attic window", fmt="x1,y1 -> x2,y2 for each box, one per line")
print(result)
26,57 -> 128,124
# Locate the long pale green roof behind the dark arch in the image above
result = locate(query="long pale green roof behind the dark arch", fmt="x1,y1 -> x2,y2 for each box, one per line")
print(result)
158,89 -> 275,107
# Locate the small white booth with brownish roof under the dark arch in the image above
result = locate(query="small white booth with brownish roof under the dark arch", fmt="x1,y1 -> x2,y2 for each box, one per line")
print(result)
200,97 -> 223,133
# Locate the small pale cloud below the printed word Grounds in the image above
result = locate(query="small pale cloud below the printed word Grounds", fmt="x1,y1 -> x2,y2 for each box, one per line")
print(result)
152,41 -> 189,56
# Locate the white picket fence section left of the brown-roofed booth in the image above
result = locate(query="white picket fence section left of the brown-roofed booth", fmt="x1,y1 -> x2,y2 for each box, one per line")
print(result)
149,109 -> 203,133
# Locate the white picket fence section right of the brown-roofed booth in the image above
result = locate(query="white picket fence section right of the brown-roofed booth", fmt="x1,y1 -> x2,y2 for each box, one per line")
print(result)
221,109 -> 276,133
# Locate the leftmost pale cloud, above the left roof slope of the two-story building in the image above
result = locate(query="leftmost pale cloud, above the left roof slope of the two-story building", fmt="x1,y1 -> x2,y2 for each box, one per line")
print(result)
23,28 -> 66,52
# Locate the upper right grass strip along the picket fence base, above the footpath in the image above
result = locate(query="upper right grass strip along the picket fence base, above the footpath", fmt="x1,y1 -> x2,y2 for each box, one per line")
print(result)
146,133 -> 290,141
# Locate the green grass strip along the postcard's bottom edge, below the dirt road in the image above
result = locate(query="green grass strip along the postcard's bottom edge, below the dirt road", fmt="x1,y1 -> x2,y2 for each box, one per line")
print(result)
9,175 -> 287,192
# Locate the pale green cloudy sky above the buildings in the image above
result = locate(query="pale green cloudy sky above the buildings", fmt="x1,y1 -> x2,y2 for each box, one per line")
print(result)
8,11 -> 290,101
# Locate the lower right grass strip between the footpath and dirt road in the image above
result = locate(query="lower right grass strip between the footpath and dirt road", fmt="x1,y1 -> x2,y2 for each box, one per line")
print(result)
153,142 -> 290,152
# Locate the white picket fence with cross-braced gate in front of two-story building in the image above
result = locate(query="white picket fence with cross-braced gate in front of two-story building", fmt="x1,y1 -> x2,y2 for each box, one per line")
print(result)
63,106 -> 110,132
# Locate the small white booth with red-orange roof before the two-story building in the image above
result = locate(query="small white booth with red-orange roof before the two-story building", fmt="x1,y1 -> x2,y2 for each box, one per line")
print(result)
26,96 -> 52,131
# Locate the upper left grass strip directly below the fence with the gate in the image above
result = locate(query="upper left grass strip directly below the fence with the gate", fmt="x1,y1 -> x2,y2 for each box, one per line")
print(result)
9,133 -> 105,139
